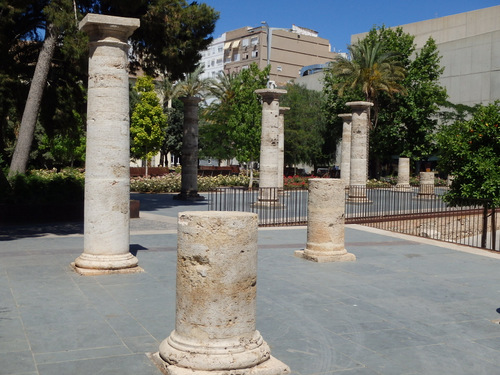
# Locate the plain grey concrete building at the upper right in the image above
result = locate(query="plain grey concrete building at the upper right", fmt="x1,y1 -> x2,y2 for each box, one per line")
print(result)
351,5 -> 500,105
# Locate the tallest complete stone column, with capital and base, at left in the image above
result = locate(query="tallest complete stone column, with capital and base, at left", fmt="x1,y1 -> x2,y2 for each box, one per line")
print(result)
74,14 -> 140,274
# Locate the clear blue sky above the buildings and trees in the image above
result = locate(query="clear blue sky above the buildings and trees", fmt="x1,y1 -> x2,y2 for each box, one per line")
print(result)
198,0 -> 500,52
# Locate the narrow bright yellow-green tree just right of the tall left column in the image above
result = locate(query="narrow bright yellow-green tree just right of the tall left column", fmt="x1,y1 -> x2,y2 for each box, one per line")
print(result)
130,76 -> 167,175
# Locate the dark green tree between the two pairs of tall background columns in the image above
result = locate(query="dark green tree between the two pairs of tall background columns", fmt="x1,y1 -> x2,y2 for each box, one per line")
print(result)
280,84 -> 328,170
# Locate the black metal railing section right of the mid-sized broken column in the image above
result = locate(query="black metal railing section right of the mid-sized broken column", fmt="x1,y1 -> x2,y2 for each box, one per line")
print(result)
346,187 -> 500,250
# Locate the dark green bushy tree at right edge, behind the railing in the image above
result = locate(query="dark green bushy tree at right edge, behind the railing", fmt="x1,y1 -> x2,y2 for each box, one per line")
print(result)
437,102 -> 500,207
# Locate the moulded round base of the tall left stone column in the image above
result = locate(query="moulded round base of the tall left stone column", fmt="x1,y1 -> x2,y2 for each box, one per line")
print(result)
71,253 -> 143,276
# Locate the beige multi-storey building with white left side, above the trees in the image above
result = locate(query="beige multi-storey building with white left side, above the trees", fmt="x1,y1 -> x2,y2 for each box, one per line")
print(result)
202,24 -> 337,85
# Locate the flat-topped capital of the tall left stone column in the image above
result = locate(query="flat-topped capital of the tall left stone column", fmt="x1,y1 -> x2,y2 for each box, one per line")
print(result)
78,13 -> 140,43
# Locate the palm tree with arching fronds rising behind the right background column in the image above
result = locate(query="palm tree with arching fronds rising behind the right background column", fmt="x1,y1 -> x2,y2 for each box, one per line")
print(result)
330,39 -> 406,125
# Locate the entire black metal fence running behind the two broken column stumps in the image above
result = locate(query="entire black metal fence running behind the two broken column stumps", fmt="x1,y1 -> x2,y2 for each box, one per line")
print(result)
208,186 -> 500,250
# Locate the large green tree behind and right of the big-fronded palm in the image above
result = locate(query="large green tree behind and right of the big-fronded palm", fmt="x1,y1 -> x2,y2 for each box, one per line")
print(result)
325,26 -> 447,176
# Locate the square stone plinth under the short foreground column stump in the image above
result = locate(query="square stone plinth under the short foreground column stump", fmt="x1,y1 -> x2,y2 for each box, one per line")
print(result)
148,352 -> 290,375
